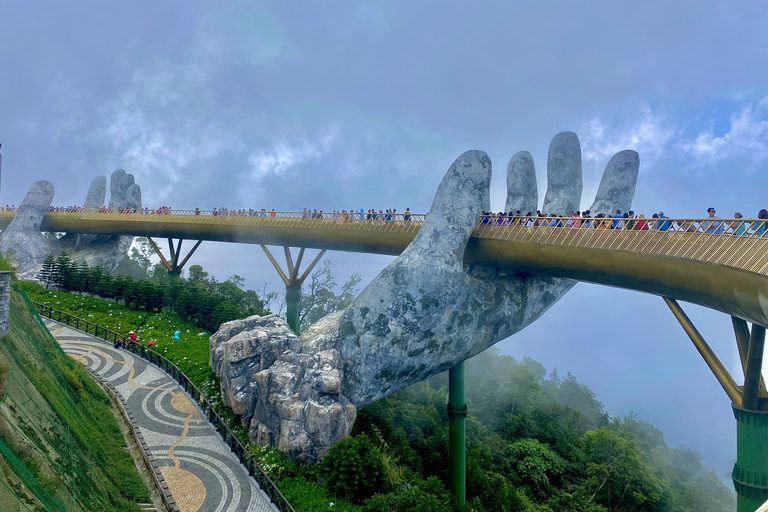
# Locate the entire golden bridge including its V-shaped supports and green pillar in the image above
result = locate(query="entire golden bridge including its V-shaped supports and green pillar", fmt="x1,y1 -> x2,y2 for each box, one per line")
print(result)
0,210 -> 768,512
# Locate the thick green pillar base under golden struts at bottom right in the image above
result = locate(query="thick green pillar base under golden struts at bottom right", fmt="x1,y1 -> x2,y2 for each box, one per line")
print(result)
732,407 -> 768,512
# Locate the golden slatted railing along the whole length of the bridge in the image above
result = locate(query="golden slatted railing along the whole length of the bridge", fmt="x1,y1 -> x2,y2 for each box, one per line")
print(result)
0,209 -> 768,275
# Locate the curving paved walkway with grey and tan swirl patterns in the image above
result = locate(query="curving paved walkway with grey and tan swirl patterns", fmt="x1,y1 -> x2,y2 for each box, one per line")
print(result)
45,319 -> 277,512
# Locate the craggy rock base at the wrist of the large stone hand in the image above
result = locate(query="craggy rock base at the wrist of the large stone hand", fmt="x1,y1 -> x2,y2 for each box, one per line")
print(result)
210,315 -> 357,460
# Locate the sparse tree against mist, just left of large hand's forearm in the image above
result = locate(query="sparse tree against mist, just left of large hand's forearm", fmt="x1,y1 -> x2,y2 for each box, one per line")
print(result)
299,259 -> 361,331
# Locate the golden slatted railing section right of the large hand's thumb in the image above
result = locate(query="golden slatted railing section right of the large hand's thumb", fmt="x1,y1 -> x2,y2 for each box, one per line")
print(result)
473,217 -> 768,275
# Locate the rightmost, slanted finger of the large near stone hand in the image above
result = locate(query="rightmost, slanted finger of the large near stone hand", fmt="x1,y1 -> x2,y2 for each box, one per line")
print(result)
589,149 -> 640,217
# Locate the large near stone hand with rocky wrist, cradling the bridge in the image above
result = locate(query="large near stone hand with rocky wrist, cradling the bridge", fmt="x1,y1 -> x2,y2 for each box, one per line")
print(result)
211,132 -> 639,459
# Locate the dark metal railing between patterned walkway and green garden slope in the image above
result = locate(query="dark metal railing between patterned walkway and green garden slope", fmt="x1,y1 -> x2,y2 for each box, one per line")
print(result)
31,301 -> 296,512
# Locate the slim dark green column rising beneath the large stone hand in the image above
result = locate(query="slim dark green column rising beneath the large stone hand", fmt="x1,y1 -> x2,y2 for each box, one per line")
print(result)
448,361 -> 467,505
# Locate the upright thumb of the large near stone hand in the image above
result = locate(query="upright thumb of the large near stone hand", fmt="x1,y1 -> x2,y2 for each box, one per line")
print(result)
403,150 -> 491,269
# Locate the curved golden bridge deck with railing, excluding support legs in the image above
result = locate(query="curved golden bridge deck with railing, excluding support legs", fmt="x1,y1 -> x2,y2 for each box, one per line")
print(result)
0,210 -> 768,327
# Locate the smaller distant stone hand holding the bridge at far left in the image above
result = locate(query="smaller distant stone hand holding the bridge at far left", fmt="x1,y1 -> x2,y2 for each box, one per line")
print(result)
0,169 -> 141,279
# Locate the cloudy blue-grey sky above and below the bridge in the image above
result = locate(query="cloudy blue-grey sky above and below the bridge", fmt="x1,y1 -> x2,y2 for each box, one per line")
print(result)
0,0 -> 768,478
